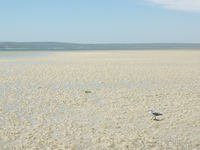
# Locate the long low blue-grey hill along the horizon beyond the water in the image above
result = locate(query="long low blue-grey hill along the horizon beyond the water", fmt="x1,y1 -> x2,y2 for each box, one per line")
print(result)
0,42 -> 200,50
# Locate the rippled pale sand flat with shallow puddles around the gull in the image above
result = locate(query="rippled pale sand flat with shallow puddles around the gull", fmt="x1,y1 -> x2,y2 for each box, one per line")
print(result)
0,50 -> 200,150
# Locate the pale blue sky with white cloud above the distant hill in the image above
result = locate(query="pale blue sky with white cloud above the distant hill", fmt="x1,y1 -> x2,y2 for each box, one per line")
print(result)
0,0 -> 200,44
